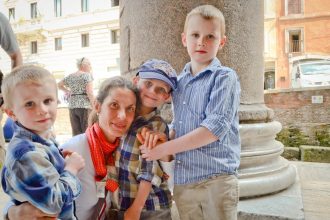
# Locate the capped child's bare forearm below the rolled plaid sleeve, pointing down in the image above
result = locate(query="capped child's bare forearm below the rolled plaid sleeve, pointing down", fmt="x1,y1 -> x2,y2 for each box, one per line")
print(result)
124,180 -> 151,220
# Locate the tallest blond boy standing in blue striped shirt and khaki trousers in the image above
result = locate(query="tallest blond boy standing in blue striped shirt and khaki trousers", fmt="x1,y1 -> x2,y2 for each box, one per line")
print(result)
141,5 -> 240,220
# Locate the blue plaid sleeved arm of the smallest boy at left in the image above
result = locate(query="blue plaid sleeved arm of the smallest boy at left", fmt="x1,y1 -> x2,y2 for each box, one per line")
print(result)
2,151 -> 81,214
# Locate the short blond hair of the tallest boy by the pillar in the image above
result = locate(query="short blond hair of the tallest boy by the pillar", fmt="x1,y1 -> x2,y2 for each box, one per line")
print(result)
184,5 -> 226,38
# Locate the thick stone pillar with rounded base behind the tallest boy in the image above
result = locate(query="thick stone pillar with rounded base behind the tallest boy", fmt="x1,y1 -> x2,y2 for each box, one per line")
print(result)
120,0 -> 296,197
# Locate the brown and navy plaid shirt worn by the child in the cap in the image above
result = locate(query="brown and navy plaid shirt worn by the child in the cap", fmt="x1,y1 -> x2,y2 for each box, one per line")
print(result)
116,111 -> 172,211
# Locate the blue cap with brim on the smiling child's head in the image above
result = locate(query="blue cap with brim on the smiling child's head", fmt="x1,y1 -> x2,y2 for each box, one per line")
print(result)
136,59 -> 177,90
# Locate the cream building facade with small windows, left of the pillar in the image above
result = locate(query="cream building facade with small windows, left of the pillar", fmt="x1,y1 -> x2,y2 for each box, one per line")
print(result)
0,0 -> 120,88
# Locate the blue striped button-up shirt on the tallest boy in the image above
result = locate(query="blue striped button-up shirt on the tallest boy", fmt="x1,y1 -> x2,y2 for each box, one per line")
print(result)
172,58 -> 241,184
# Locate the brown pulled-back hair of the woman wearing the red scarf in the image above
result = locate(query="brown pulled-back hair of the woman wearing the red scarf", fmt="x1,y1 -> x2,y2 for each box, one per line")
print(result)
88,76 -> 139,126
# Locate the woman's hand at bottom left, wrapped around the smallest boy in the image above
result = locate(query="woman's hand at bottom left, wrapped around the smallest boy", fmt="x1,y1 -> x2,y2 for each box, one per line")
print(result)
8,202 -> 57,220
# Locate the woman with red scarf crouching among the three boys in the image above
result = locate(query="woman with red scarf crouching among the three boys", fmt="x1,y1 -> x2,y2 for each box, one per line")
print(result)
8,77 -> 137,220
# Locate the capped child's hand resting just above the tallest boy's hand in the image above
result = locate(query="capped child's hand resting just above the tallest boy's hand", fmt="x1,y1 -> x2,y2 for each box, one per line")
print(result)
136,127 -> 167,149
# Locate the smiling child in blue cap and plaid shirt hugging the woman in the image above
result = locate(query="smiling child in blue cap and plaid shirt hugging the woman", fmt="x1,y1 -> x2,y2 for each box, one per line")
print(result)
116,59 -> 176,220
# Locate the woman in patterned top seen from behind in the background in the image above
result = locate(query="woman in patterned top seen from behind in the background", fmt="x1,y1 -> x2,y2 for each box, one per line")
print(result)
58,57 -> 94,136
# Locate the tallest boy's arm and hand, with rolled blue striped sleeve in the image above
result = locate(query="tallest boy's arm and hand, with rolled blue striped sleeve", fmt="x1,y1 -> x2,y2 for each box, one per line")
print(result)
140,71 -> 240,160
